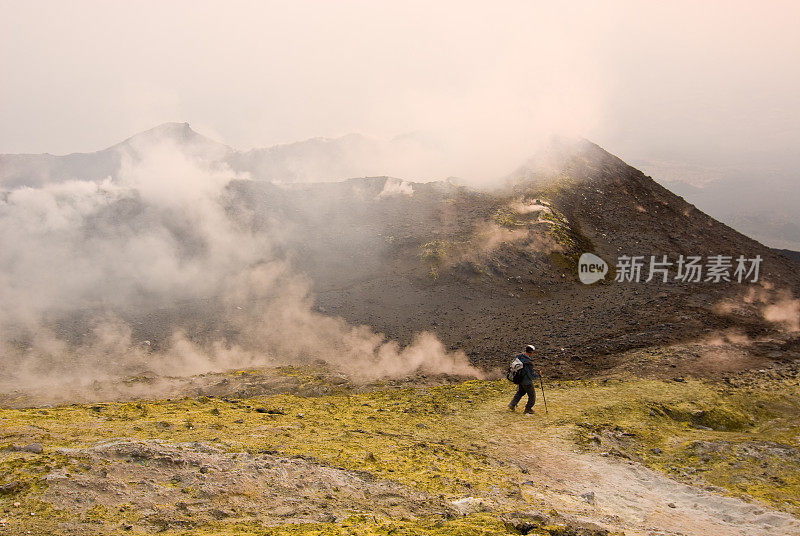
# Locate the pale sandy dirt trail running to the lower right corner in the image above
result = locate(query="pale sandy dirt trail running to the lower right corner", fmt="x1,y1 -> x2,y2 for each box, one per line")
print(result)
519,440 -> 800,536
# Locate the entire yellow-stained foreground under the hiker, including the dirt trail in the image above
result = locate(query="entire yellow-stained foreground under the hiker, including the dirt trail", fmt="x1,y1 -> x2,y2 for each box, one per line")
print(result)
0,369 -> 800,535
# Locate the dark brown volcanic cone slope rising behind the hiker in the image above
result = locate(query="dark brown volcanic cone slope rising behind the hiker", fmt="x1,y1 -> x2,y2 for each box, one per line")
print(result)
212,142 -> 798,378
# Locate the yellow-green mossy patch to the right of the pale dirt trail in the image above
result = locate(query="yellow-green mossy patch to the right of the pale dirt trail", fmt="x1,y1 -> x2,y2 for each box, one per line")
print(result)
574,381 -> 800,514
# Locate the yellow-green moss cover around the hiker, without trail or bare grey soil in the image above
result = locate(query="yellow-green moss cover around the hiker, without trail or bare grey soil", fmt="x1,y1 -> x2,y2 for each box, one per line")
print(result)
0,369 -> 800,534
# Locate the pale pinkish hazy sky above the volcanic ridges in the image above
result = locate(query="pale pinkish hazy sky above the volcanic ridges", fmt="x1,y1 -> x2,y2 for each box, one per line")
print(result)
0,0 -> 800,174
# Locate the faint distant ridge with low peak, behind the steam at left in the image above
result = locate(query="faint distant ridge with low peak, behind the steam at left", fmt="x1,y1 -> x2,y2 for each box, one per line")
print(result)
0,122 -> 441,189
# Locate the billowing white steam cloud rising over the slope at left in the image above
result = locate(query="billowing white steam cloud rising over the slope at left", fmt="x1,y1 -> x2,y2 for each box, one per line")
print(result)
0,143 -> 477,400
